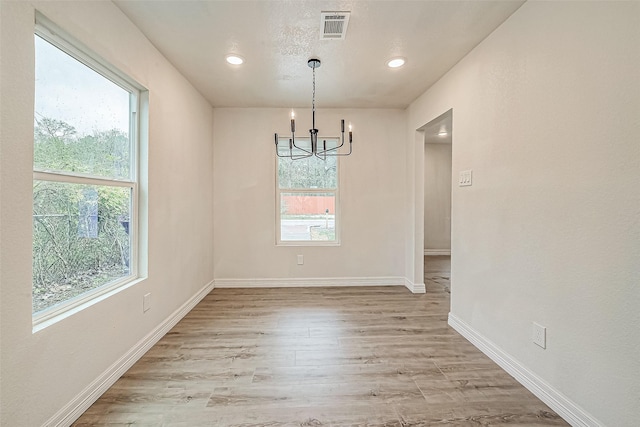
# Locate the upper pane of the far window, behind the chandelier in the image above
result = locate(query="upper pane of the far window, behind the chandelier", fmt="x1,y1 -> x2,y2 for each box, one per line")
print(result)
278,138 -> 338,189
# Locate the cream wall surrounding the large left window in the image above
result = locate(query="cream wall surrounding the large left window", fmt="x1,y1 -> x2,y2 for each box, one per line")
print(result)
0,1 -> 213,426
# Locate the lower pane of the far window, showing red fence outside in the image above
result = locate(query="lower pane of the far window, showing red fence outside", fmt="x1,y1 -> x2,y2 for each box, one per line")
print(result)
280,193 -> 336,241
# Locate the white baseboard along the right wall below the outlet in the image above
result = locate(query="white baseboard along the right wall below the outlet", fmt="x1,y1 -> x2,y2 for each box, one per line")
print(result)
449,313 -> 604,427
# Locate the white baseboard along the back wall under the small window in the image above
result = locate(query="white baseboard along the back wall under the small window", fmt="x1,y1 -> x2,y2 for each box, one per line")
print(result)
214,277 -> 405,288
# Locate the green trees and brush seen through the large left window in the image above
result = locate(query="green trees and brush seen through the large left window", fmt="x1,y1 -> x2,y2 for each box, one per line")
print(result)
33,118 -> 132,313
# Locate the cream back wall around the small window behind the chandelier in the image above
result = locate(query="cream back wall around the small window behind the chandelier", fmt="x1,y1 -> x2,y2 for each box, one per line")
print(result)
214,108 -> 406,286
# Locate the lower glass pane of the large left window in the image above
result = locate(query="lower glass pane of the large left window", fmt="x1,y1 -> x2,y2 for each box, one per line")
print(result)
33,181 -> 131,313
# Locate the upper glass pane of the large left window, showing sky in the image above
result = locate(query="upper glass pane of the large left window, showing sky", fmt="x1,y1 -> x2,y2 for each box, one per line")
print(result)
34,36 -> 132,180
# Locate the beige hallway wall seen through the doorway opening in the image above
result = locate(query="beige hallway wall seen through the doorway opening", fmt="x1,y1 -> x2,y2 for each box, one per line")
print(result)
424,143 -> 451,253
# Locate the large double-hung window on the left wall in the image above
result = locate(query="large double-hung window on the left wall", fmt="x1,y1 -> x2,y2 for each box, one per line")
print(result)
32,18 -> 139,323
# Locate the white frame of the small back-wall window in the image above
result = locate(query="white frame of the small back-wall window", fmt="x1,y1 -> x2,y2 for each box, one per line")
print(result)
274,137 -> 341,246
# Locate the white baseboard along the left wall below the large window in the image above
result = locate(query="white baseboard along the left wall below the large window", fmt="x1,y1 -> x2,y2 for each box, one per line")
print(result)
44,282 -> 214,427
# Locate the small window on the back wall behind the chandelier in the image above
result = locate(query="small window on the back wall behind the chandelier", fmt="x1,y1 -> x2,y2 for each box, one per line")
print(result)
276,137 -> 339,245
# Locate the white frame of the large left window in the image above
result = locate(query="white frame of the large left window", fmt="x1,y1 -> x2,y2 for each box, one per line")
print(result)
32,12 -> 144,332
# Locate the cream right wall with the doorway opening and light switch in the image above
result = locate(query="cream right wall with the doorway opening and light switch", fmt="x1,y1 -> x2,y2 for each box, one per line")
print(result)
407,2 -> 640,427
